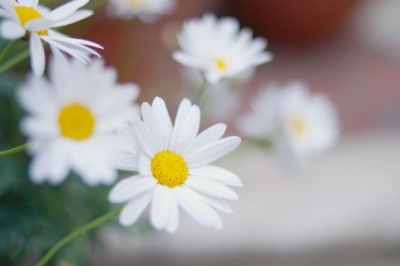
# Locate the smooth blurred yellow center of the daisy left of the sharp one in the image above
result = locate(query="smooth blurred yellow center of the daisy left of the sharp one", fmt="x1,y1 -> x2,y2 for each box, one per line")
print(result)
58,103 -> 96,140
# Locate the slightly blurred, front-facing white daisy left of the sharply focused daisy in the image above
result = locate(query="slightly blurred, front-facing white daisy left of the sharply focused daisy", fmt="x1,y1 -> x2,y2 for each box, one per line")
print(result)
17,58 -> 139,185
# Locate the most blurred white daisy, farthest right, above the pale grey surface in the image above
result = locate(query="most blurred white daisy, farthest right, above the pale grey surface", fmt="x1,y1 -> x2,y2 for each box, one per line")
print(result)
238,82 -> 339,161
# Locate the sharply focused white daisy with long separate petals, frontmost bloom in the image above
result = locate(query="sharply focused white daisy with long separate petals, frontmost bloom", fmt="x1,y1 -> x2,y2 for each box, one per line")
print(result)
109,98 -> 242,232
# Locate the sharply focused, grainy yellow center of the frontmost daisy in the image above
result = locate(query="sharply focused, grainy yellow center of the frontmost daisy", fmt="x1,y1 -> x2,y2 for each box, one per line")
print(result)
151,151 -> 189,187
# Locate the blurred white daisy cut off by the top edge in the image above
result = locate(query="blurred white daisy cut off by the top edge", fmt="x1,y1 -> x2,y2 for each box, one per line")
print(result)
109,0 -> 176,22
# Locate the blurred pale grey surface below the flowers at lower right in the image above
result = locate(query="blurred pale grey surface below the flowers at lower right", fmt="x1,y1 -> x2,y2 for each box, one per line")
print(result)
90,131 -> 400,266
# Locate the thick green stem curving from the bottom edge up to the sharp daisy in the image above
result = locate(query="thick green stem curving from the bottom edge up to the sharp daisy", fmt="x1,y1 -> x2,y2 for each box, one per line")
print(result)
36,207 -> 122,266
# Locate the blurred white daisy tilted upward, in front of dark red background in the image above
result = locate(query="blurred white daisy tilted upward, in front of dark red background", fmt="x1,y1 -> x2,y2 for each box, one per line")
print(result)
173,14 -> 272,84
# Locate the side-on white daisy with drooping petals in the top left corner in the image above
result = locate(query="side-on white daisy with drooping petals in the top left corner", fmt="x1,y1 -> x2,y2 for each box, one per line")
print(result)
0,0 -> 103,76
